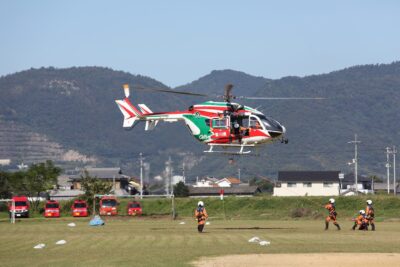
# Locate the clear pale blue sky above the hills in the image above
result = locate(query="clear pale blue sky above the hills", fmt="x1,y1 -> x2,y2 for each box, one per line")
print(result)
0,0 -> 400,86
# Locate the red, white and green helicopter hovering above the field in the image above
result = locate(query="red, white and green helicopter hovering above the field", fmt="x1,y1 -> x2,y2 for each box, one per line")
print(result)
115,84 -> 323,155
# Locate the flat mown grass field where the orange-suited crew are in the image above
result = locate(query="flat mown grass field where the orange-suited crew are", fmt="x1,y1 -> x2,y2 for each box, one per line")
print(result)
0,217 -> 400,266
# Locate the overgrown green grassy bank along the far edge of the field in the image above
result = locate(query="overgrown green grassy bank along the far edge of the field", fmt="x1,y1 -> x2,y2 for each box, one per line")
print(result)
1,195 -> 400,221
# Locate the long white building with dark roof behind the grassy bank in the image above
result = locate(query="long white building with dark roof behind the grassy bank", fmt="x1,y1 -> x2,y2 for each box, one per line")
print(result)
274,171 -> 340,196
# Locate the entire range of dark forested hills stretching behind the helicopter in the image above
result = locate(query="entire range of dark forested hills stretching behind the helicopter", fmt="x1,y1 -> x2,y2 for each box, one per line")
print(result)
0,62 -> 400,179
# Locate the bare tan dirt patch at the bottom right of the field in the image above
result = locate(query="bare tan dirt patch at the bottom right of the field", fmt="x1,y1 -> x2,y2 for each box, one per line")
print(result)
193,253 -> 400,267
